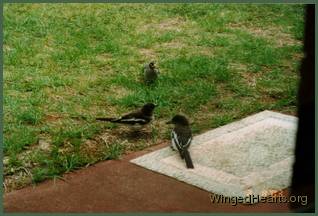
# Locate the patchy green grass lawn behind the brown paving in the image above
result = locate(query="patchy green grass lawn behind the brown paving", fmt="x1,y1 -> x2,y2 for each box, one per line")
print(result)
3,4 -> 304,191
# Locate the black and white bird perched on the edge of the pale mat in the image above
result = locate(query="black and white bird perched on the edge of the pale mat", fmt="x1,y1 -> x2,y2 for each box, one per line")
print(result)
167,115 -> 194,169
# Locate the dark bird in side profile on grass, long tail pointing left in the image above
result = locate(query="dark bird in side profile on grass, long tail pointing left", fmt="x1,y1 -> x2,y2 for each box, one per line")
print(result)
96,103 -> 156,125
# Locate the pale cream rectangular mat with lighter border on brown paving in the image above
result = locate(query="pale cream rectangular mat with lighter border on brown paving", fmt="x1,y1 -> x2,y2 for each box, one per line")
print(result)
131,111 -> 297,196
